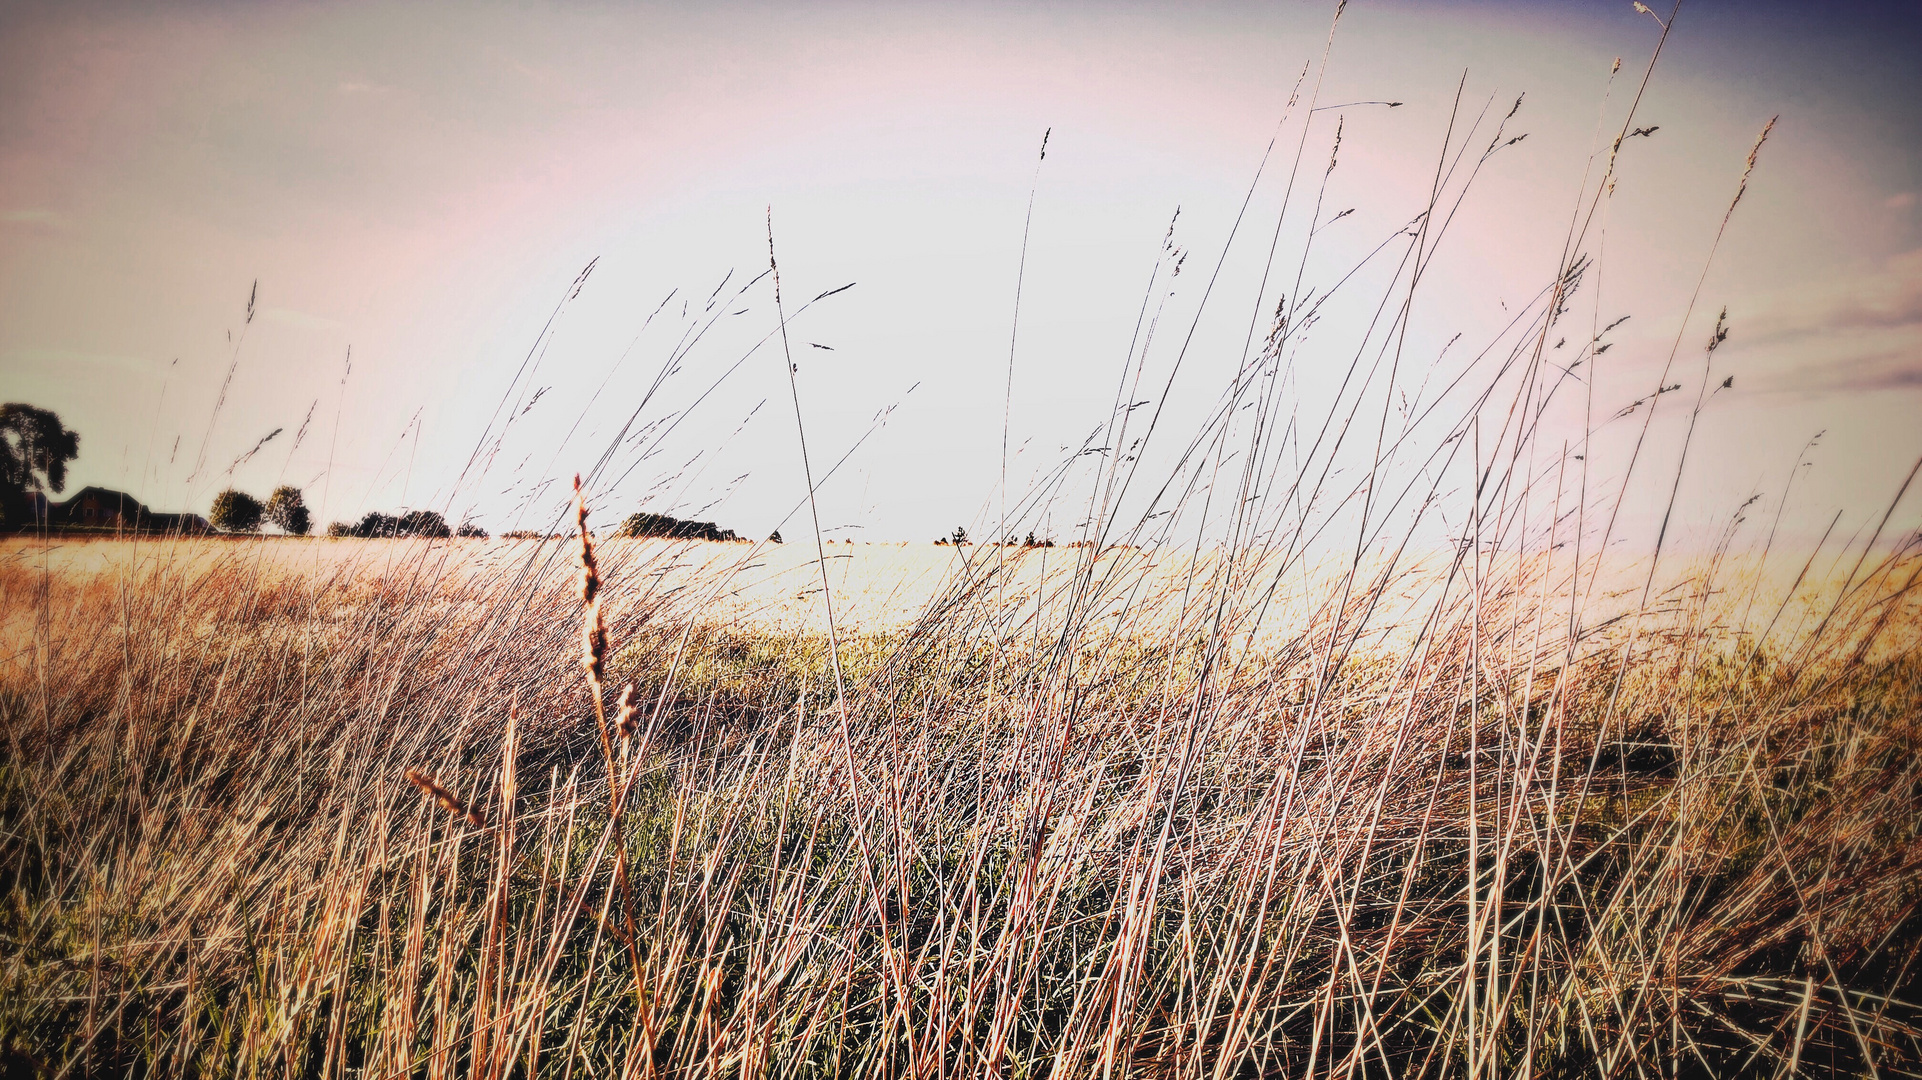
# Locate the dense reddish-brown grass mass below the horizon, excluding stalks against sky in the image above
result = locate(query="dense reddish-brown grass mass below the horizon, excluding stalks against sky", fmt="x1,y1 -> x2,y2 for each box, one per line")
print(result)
0,495 -> 1922,1076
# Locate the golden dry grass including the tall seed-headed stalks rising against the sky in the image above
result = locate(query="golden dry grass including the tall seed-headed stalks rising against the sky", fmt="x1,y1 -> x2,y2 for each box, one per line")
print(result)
0,6 -> 1922,1078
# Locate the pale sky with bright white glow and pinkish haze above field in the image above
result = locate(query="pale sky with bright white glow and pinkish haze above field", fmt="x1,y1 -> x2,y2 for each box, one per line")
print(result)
0,0 -> 1922,540
